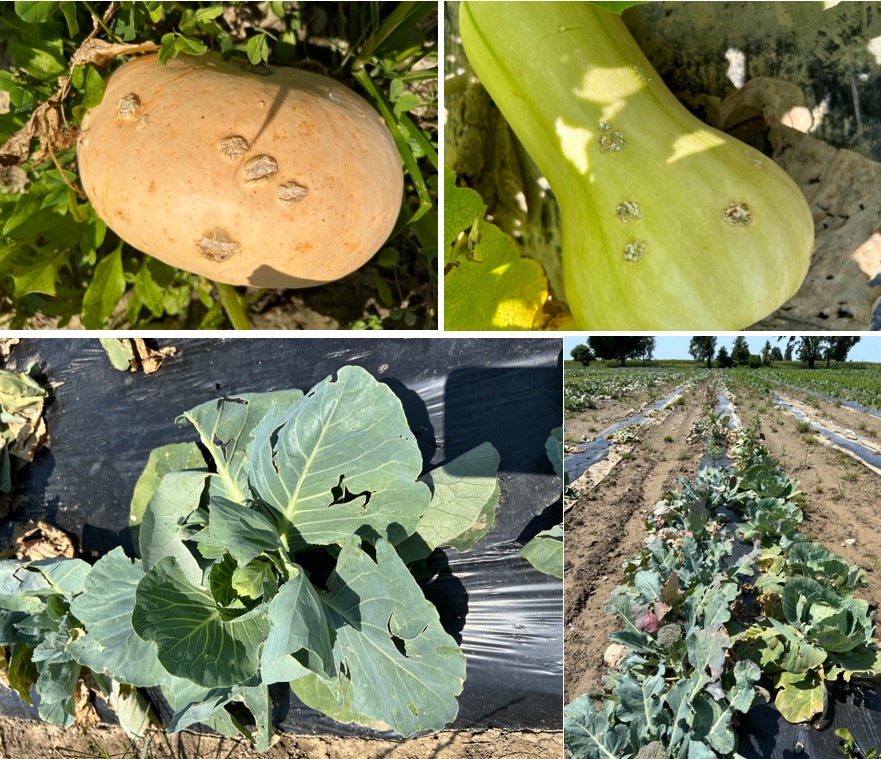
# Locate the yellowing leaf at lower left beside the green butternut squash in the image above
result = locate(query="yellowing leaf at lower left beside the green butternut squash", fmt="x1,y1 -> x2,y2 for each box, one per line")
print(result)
444,217 -> 548,330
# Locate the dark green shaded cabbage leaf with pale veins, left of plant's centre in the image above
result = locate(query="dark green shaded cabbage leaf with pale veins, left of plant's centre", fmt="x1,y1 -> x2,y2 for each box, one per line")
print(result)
132,556 -> 269,688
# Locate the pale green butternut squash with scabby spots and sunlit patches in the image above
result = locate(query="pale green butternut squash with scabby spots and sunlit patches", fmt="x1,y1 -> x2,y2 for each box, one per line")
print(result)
459,2 -> 814,330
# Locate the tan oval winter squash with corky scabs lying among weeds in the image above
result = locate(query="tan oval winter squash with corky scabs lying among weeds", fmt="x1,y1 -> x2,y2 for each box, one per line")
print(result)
78,54 -> 403,288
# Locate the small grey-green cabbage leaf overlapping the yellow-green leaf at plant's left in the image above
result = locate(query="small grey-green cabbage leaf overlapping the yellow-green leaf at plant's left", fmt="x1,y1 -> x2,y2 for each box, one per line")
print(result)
138,472 -> 208,583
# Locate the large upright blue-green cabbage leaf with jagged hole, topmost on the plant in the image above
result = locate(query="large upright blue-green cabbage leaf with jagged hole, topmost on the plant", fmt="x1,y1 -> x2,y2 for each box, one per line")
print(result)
250,366 -> 430,547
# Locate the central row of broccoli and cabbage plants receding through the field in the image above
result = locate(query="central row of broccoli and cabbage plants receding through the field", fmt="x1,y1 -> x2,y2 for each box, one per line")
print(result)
564,391 -> 881,759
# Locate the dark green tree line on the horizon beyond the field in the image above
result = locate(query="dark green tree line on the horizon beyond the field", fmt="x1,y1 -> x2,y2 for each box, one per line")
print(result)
571,335 -> 860,369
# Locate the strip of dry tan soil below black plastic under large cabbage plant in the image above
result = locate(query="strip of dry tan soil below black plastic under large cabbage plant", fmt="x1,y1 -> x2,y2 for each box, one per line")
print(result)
0,718 -> 563,759
